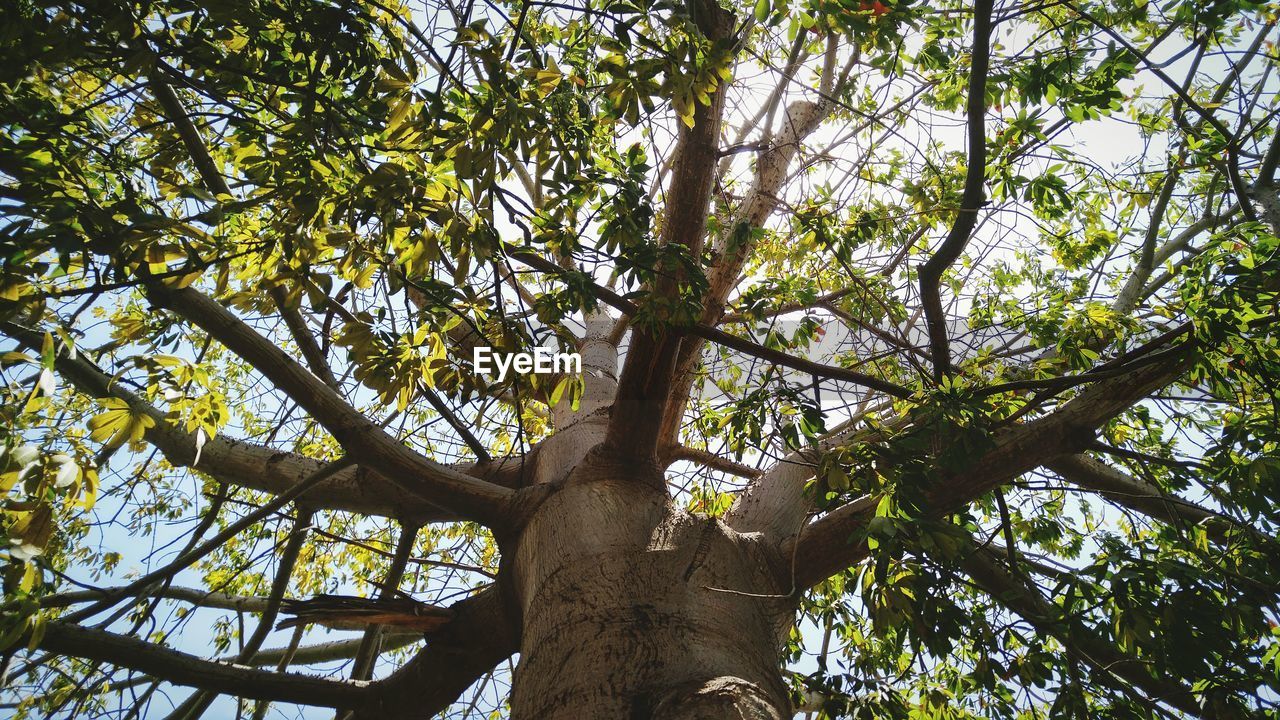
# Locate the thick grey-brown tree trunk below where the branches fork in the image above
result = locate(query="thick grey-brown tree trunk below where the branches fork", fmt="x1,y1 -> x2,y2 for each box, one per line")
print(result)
511,450 -> 794,720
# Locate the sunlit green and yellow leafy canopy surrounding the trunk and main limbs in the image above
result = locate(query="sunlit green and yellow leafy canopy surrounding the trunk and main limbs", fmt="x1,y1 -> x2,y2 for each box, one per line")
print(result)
0,0 -> 1280,719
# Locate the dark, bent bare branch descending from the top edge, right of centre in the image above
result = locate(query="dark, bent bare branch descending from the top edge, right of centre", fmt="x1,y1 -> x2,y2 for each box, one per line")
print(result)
920,0 -> 993,379
